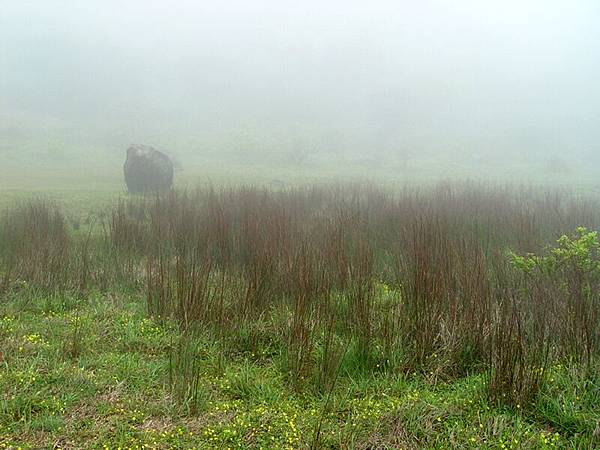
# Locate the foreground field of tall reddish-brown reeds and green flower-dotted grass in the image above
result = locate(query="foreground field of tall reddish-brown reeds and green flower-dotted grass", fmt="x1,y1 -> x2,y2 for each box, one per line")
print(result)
0,181 -> 600,449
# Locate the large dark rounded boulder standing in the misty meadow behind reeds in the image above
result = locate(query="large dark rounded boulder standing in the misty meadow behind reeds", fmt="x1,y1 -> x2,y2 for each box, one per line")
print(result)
123,145 -> 173,194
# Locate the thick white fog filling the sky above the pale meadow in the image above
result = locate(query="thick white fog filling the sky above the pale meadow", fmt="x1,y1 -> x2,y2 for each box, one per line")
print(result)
0,0 -> 600,181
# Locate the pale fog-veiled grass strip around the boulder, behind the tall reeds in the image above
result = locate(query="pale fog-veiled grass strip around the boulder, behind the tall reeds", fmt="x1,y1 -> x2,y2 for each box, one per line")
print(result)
0,141 -> 600,195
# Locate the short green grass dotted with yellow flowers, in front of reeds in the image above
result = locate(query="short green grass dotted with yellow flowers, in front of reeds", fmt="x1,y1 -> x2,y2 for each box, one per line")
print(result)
0,285 -> 600,449
